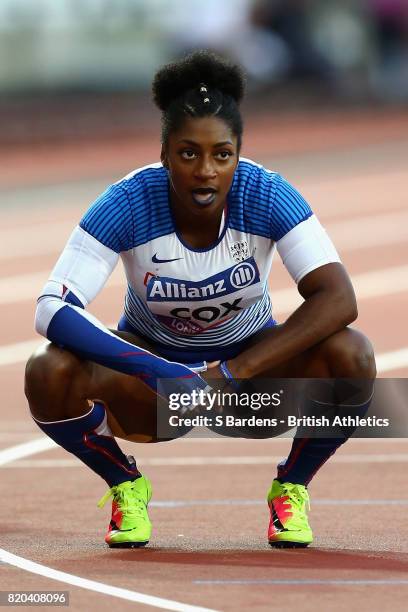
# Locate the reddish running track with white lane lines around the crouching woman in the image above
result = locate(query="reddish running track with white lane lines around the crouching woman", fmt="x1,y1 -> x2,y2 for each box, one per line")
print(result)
0,113 -> 408,612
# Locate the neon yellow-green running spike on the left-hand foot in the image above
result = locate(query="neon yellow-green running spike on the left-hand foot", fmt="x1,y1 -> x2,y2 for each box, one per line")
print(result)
98,476 -> 152,548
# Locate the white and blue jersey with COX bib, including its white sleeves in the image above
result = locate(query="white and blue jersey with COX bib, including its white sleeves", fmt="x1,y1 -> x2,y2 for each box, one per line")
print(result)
37,159 -> 339,380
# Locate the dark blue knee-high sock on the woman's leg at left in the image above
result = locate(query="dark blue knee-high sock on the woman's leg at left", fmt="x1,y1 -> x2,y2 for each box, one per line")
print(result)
34,402 -> 140,487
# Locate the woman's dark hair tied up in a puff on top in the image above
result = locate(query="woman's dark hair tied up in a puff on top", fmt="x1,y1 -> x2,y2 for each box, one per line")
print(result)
152,51 -> 245,151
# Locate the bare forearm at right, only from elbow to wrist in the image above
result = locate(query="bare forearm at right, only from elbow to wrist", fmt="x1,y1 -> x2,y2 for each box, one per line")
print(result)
228,290 -> 357,378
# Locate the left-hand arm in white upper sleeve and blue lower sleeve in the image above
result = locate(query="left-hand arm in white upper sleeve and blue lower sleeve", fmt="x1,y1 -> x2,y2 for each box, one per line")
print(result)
35,194 -> 209,391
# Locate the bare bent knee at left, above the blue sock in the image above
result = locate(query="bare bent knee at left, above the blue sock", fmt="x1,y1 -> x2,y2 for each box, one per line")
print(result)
24,344 -> 81,420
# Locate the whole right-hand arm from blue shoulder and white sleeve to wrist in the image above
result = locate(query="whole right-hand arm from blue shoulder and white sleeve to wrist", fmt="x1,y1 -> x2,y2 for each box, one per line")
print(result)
228,172 -> 357,378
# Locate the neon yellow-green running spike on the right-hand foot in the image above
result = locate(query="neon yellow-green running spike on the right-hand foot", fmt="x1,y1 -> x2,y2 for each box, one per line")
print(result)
267,480 -> 313,548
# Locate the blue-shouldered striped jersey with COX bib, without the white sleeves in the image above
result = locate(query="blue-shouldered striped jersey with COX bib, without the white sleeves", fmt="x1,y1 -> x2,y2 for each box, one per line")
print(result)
80,159 -> 313,348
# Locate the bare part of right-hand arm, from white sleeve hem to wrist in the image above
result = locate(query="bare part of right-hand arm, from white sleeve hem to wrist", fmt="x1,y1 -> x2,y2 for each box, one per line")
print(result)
228,263 -> 357,378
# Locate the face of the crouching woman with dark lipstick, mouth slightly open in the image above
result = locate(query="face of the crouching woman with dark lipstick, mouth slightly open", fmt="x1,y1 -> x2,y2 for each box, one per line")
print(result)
162,117 -> 238,216
